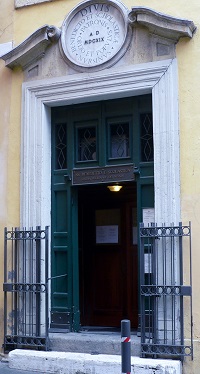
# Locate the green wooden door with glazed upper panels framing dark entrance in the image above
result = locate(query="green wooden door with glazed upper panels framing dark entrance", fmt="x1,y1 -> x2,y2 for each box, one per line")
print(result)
51,95 -> 154,331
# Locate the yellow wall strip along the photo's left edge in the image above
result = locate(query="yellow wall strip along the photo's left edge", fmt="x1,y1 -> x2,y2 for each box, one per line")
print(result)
0,0 -> 14,346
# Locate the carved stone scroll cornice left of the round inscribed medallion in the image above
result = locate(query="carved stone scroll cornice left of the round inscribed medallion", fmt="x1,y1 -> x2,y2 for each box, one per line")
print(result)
1,25 -> 61,70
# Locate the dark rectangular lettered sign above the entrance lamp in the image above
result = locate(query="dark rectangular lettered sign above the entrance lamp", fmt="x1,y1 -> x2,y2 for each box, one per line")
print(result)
72,165 -> 135,185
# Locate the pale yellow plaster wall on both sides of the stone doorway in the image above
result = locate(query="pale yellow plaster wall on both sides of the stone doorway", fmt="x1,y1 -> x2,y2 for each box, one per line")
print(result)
0,0 -> 200,374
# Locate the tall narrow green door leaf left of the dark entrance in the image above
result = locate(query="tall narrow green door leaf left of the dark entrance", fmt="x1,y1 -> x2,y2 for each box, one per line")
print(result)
51,183 -> 72,327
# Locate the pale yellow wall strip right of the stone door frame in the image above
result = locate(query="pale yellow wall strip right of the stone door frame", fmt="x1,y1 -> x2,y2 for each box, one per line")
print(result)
177,32 -> 200,374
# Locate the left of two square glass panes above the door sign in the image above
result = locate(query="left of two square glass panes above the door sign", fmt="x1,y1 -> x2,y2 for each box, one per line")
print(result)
77,126 -> 96,161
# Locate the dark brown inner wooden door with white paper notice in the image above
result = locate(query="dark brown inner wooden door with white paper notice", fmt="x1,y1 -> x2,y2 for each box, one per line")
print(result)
79,183 -> 138,327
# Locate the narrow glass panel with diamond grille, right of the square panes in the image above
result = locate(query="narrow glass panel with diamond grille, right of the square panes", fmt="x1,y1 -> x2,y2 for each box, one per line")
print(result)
140,113 -> 153,162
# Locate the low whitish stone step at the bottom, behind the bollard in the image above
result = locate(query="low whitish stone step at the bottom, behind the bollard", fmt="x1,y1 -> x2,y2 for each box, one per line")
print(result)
9,349 -> 182,374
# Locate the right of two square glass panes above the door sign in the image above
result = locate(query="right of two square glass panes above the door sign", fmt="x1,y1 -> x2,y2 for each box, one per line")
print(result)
109,123 -> 130,158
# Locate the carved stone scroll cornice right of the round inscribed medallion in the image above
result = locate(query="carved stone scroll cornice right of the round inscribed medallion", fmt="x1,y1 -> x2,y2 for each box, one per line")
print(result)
128,6 -> 196,42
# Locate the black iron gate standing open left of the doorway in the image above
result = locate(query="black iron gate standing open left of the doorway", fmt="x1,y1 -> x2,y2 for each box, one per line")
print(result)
3,226 -> 48,352
